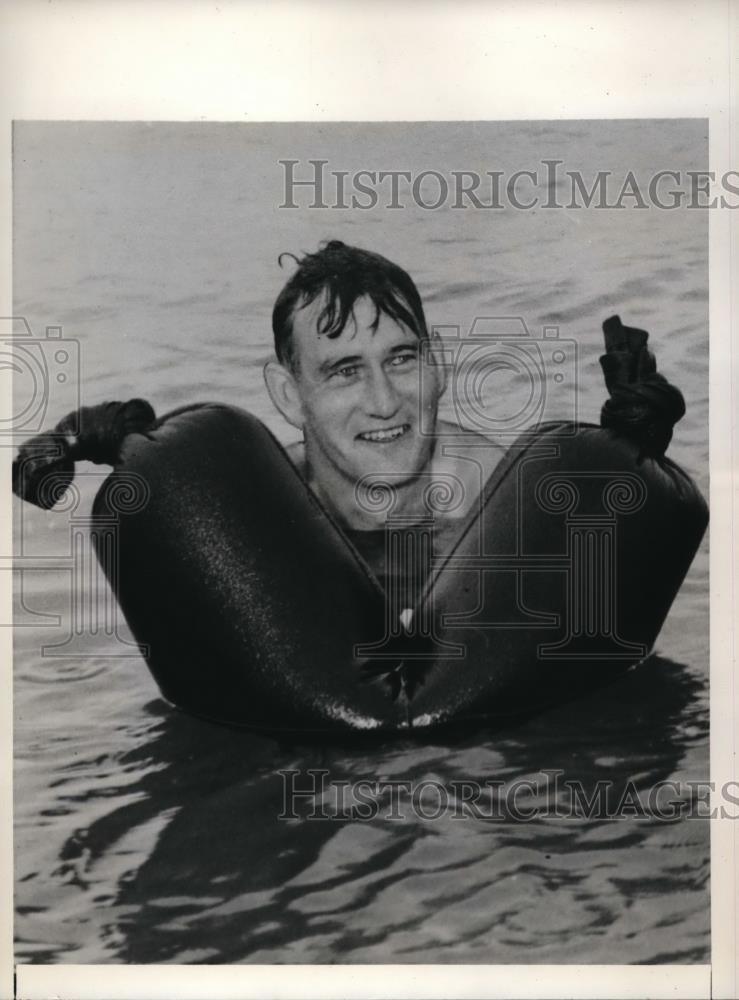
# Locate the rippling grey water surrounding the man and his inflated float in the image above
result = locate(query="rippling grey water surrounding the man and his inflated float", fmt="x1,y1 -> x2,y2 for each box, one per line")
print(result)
10,121 -> 710,963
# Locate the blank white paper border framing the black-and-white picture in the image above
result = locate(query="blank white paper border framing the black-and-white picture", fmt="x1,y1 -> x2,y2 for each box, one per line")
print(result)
0,0 -> 739,1000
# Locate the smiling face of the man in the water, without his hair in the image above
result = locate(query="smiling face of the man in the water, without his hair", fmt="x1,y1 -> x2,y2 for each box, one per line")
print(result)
280,298 -> 443,498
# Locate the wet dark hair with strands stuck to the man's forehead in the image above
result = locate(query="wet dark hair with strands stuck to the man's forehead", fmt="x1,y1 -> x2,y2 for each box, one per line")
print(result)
272,240 -> 428,370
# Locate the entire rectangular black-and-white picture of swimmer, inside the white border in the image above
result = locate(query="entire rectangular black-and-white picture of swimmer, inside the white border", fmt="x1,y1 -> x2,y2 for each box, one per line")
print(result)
13,119 -> 712,965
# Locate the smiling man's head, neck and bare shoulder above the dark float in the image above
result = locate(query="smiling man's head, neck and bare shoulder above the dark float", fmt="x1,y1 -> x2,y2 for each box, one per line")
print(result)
264,240 -> 500,531
